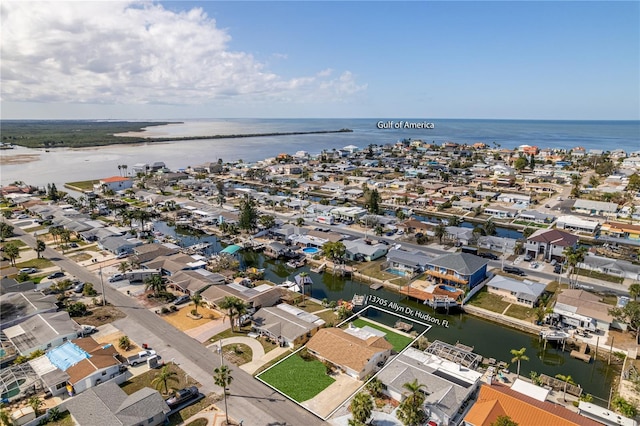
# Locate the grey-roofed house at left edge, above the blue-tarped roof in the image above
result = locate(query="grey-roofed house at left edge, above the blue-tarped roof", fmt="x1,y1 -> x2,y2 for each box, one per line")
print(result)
3,311 -> 80,356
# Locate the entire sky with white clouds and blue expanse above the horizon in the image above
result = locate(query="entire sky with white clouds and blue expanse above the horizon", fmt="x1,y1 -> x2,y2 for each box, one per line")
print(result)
0,1 -> 640,120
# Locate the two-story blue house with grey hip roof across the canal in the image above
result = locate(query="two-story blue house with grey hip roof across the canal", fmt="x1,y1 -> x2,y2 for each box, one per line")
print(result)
425,253 -> 489,290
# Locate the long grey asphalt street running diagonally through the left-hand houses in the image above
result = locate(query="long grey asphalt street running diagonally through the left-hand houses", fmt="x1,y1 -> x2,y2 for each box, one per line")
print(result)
14,228 -> 325,426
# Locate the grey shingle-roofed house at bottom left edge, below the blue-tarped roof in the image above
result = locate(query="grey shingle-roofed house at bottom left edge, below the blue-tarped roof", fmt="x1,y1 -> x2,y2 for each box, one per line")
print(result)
66,382 -> 170,426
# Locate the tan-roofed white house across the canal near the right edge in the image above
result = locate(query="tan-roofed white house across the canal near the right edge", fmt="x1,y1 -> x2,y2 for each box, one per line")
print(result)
553,289 -> 621,332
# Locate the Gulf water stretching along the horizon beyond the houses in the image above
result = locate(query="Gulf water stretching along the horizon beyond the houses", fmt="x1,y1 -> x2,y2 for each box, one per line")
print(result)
0,118 -> 640,186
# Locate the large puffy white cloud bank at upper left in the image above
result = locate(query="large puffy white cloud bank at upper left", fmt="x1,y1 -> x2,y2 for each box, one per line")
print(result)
0,1 -> 366,105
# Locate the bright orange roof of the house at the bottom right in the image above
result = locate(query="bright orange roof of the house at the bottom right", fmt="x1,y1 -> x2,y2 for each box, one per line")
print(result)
462,383 -> 600,426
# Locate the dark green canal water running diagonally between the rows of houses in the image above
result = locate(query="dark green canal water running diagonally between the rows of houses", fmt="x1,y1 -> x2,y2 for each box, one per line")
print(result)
155,222 -> 619,405
